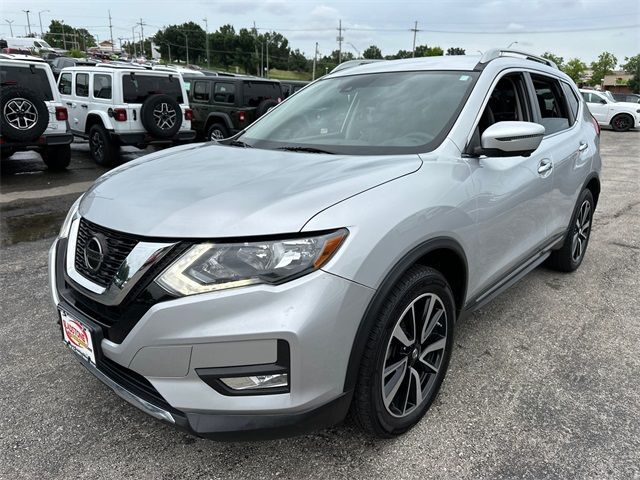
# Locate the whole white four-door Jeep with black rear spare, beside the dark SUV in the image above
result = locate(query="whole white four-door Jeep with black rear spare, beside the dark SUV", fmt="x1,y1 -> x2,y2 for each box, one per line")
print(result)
58,64 -> 195,166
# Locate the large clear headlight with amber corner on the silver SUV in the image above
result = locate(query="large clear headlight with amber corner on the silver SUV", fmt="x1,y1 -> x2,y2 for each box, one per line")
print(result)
156,229 -> 348,295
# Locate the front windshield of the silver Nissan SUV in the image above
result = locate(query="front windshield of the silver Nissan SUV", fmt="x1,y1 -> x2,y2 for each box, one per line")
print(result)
239,71 -> 478,155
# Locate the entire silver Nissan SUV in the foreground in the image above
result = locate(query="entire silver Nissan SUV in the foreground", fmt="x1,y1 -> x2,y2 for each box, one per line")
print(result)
50,50 -> 601,438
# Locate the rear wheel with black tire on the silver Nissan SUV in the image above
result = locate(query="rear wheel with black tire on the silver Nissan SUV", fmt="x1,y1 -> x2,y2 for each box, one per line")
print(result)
546,189 -> 596,272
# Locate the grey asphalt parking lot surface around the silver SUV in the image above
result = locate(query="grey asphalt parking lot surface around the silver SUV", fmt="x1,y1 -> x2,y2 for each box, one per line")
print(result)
0,131 -> 640,479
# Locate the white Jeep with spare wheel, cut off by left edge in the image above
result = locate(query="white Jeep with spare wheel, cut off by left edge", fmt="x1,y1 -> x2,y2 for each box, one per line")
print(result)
0,55 -> 73,170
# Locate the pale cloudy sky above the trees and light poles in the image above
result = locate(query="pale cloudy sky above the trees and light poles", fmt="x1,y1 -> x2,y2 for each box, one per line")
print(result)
0,0 -> 640,63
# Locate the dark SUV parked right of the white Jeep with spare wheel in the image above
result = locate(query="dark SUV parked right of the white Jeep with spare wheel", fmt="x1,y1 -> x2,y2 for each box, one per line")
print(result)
183,75 -> 283,140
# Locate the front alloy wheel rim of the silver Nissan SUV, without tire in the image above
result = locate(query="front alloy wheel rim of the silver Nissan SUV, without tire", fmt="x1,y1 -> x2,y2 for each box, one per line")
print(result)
381,293 -> 447,418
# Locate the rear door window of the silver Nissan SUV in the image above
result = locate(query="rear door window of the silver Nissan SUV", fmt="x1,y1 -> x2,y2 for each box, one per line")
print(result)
531,75 -> 571,135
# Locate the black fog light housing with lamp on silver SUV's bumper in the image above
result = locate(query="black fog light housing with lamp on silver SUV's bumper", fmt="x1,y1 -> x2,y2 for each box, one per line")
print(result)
196,340 -> 291,396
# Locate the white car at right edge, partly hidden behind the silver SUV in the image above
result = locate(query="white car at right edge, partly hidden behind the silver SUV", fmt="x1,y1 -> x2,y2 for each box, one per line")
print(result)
580,89 -> 640,132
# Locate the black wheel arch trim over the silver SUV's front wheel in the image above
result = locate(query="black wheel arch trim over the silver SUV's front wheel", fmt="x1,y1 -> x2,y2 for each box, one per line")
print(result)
344,237 -> 469,392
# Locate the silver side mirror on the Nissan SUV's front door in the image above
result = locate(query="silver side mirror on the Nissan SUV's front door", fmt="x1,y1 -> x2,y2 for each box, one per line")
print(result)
477,122 -> 545,157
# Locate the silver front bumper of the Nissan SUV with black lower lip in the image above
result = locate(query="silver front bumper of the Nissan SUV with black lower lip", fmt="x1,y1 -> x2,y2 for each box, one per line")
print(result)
49,236 -> 373,438
